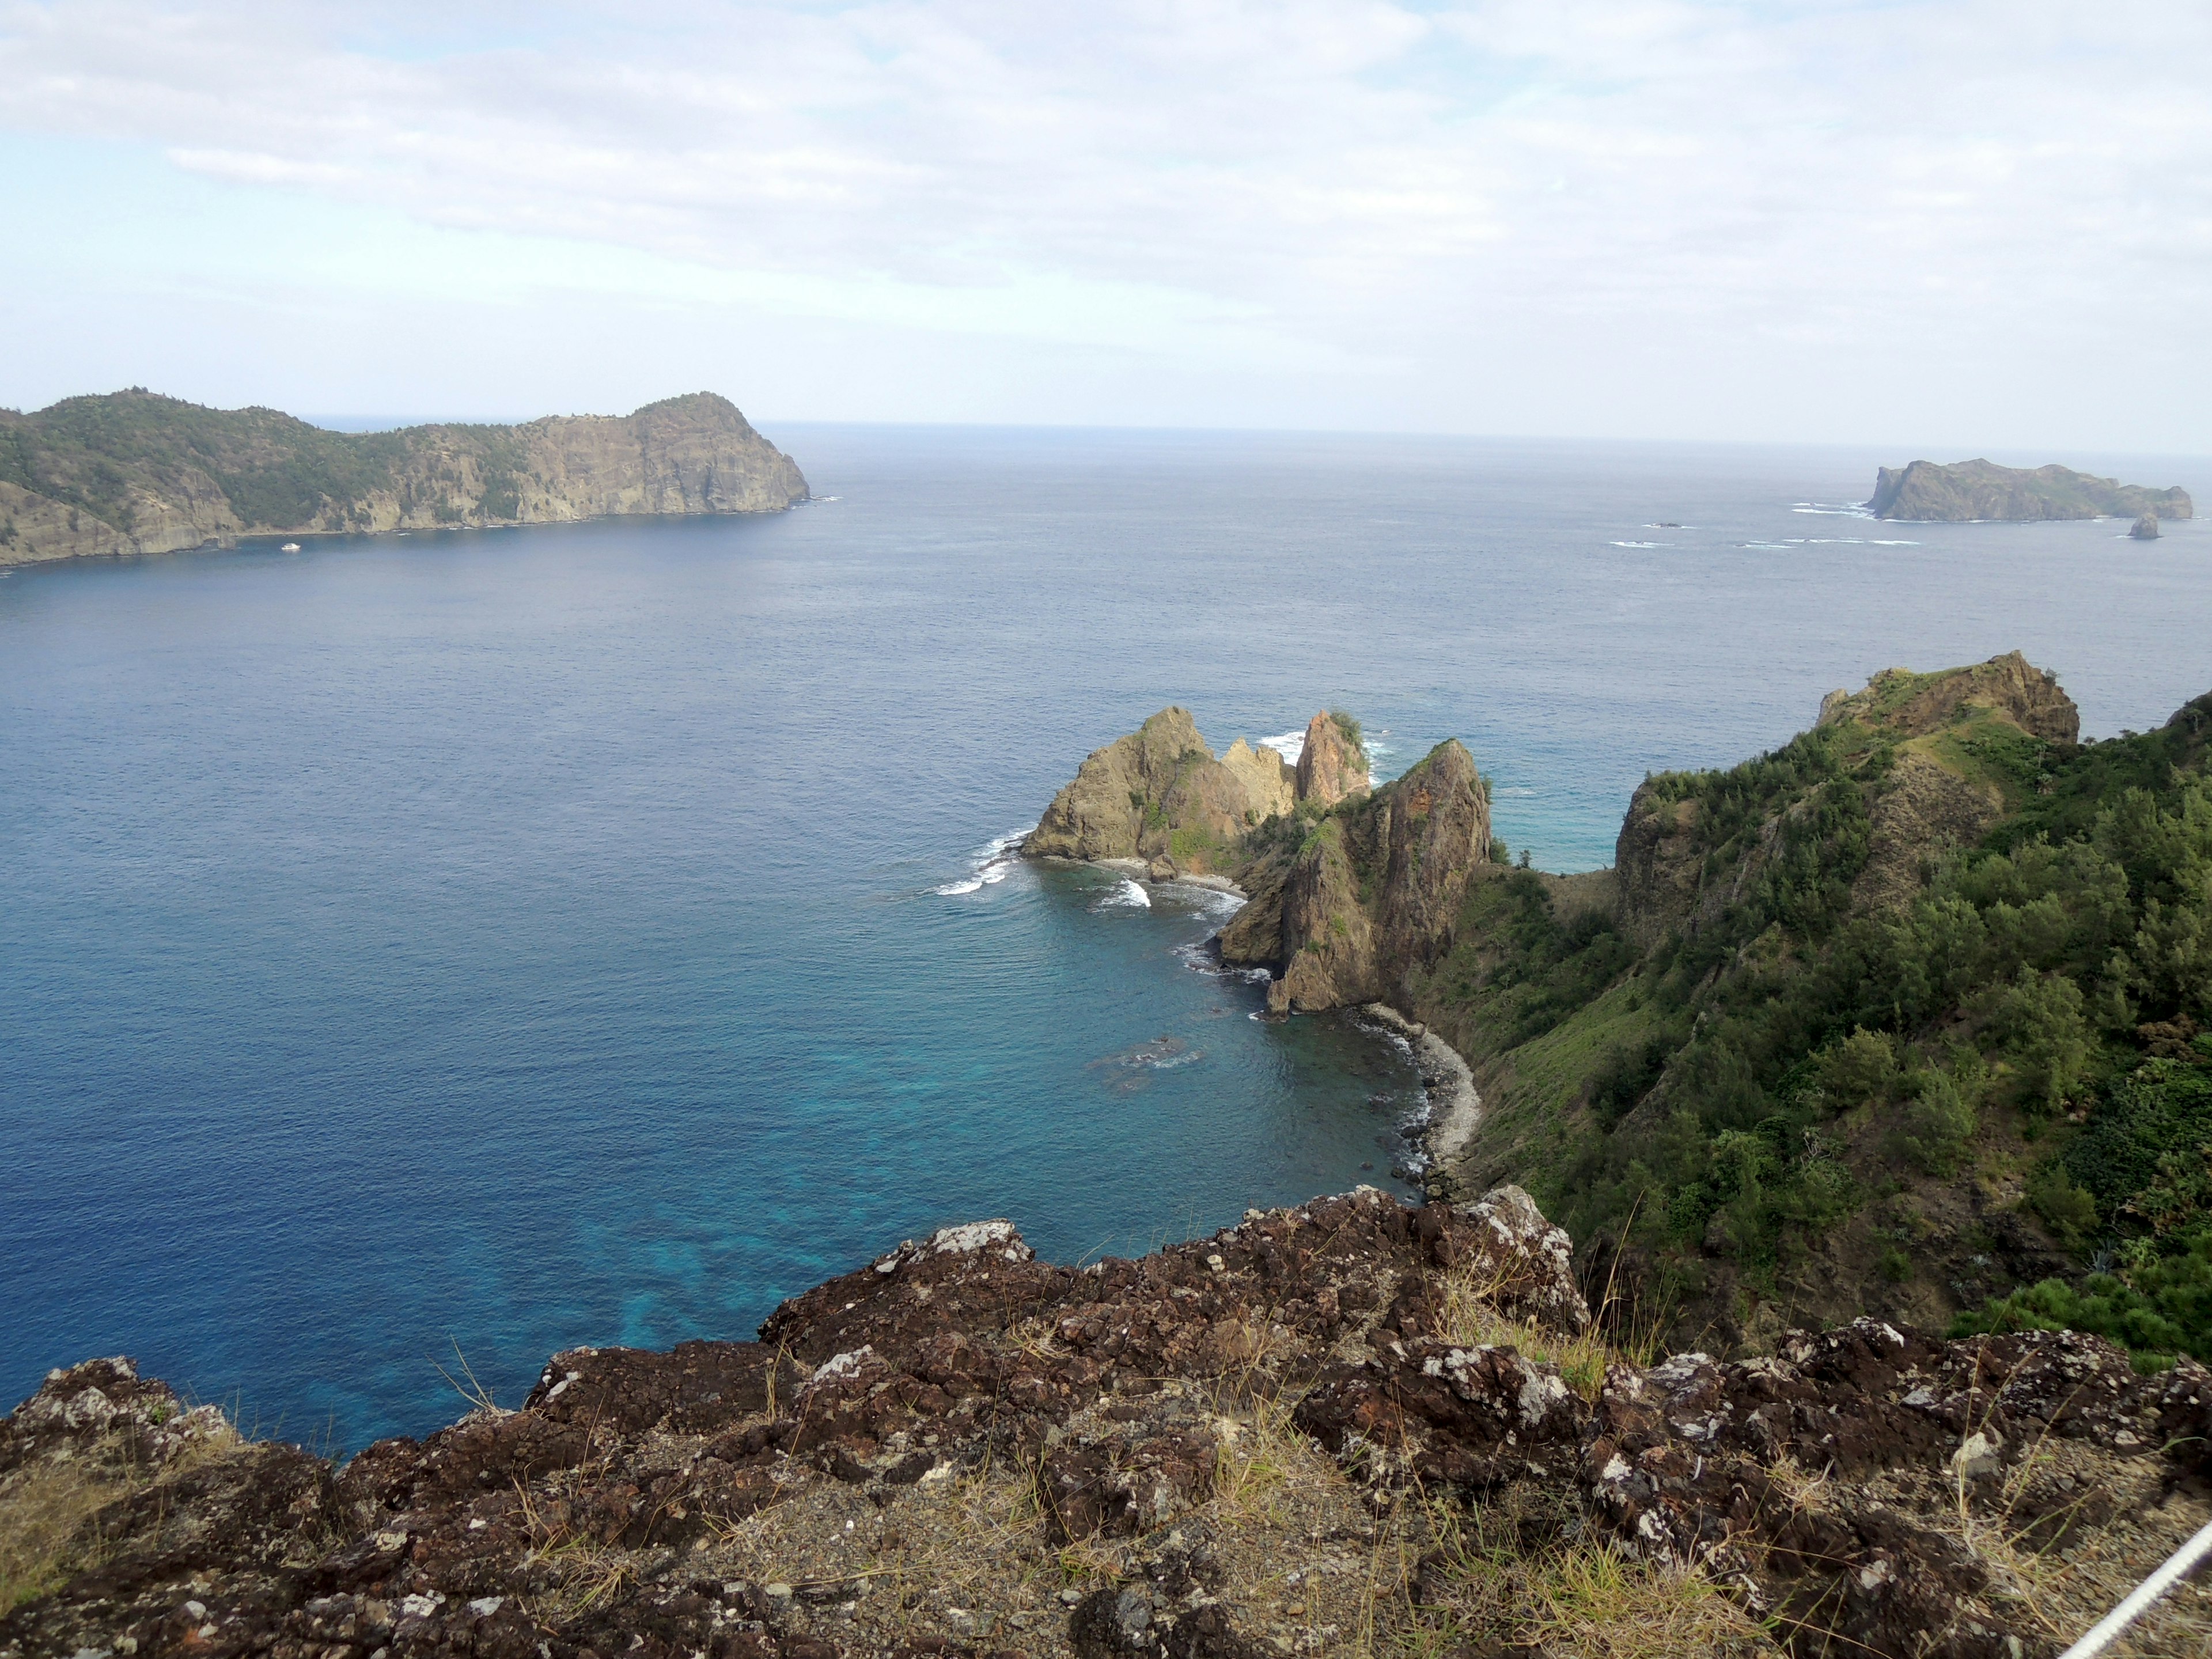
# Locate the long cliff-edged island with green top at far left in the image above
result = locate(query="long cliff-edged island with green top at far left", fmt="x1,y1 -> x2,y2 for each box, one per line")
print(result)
0,387 -> 808,564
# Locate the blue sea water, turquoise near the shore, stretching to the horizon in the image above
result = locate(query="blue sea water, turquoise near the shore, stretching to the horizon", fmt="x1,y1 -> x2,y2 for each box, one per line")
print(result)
0,427 -> 2212,1446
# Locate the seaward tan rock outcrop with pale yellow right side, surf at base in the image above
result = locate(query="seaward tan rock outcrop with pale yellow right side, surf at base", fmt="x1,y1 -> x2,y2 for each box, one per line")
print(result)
1022,706 -> 1292,876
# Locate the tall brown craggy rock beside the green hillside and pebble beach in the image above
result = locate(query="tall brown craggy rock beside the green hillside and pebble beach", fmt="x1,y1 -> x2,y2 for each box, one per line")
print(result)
1221,739 -> 1491,1011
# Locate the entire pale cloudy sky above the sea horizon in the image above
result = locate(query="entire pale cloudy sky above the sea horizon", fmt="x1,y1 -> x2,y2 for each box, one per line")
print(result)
0,0 -> 2212,458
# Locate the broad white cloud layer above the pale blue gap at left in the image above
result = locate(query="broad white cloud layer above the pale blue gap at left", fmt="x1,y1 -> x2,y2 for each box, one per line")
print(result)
0,0 -> 2212,447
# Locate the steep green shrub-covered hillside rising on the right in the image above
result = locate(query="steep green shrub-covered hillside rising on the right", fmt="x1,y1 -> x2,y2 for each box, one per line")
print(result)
1418,655 -> 2212,1358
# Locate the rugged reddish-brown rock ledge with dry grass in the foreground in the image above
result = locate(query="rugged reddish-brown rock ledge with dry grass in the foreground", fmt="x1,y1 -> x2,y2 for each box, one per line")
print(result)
0,1190 -> 2212,1659
